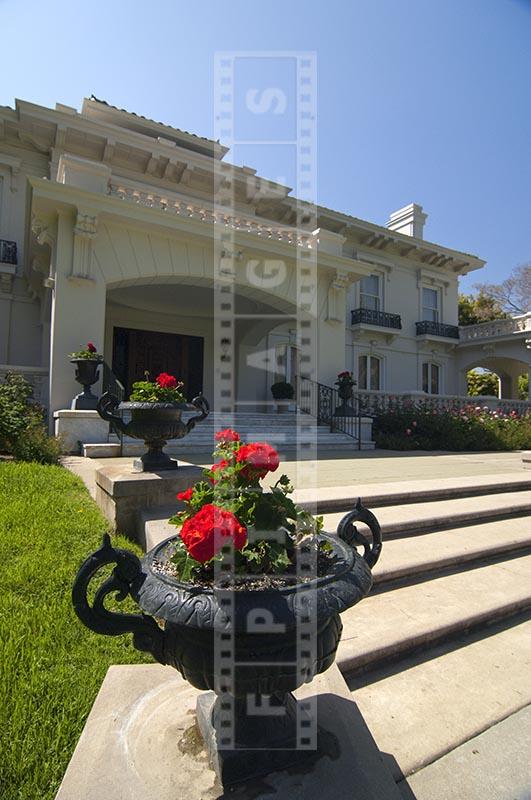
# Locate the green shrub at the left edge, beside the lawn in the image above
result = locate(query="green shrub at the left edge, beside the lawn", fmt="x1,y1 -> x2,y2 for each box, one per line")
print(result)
0,372 -> 61,464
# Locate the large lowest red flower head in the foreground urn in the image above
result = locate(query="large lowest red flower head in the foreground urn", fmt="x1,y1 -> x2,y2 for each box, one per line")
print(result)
181,503 -> 247,564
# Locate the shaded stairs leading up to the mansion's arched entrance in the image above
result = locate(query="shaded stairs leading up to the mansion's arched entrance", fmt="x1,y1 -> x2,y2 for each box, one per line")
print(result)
82,412 -> 374,458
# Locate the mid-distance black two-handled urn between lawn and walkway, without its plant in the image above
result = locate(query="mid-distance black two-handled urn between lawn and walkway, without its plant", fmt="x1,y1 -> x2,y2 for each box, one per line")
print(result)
97,392 -> 210,472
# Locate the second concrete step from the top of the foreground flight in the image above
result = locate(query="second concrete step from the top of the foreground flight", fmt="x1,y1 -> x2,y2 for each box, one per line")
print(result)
324,491 -> 531,537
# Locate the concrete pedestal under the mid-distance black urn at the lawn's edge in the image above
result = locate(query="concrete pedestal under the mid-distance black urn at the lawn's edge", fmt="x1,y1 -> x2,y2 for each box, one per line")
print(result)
95,461 -> 203,547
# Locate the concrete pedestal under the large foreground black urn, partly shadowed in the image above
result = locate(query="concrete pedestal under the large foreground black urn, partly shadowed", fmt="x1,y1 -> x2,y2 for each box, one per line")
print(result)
56,665 -> 401,800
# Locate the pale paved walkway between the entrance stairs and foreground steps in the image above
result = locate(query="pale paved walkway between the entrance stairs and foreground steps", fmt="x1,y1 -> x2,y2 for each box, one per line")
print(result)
63,450 -> 523,496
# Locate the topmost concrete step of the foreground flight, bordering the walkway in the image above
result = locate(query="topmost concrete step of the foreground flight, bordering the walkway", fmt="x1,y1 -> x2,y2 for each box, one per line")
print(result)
293,472 -> 531,514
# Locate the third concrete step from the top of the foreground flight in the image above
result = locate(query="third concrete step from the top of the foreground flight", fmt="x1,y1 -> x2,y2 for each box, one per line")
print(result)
373,516 -> 531,587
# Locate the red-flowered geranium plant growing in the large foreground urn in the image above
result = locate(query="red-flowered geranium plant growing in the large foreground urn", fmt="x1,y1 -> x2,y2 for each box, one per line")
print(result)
170,428 -> 331,583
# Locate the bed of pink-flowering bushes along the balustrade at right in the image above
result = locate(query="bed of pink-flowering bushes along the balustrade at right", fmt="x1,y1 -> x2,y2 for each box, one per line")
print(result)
373,401 -> 531,451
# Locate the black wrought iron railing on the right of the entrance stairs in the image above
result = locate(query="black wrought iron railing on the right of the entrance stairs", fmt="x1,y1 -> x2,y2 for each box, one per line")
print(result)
295,377 -> 366,450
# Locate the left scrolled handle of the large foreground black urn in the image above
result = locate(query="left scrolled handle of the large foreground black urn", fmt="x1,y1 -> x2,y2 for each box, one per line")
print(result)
72,533 -> 165,664
